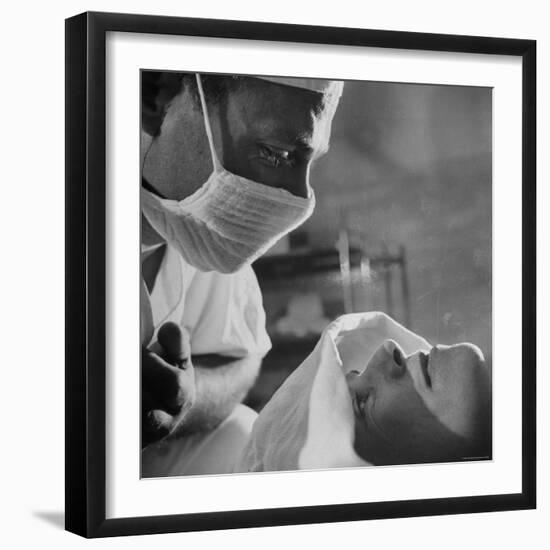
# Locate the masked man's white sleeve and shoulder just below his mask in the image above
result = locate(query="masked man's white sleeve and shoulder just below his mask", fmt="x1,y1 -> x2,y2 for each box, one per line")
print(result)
141,245 -> 271,357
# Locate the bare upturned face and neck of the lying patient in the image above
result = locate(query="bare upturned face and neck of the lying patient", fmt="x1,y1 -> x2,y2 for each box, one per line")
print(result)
347,340 -> 491,464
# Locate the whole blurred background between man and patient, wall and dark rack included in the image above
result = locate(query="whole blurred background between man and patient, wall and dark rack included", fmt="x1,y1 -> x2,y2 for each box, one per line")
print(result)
247,82 -> 492,410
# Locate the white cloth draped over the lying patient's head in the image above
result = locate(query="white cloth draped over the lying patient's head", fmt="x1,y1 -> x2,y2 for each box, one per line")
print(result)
236,312 -> 431,472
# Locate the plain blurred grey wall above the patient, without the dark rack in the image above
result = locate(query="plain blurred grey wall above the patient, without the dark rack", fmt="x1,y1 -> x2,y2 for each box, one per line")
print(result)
304,82 -> 492,358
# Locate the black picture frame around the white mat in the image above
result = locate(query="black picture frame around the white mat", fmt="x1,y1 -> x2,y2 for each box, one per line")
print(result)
65,13 -> 536,537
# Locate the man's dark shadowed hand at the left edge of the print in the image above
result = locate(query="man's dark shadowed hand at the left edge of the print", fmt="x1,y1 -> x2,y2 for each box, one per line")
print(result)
141,322 -> 196,448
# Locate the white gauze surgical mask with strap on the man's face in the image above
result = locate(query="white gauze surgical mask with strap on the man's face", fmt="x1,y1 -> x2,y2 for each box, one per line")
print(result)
141,74 -> 315,273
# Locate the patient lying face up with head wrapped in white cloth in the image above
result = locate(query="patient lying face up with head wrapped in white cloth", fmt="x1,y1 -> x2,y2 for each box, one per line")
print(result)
236,312 -> 491,472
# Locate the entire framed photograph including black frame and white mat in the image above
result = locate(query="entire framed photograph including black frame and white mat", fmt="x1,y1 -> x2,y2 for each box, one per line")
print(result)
60,7 -> 537,546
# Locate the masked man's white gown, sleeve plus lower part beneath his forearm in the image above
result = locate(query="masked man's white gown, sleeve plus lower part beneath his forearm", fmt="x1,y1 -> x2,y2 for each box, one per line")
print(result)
141,245 -> 271,477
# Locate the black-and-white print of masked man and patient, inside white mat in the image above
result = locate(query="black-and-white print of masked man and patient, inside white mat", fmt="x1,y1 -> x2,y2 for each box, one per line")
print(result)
140,69 -> 499,478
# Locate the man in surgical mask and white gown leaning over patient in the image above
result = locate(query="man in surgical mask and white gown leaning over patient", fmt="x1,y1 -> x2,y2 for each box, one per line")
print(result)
141,73 -> 342,477
